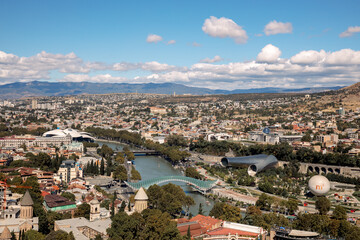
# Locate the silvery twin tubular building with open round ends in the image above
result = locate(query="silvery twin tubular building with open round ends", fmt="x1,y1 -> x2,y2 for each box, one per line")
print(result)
221,154 -> 278,176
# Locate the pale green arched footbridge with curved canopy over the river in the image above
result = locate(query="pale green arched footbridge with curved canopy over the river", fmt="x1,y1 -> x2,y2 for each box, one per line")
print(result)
125,176 -> 216,193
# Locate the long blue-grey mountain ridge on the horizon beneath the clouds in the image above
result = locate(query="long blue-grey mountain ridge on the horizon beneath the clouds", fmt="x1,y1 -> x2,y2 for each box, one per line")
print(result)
0,81 -> 341,99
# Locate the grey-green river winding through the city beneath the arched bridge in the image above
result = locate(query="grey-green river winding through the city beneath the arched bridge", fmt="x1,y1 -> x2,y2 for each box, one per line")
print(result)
97,141 -> 214,216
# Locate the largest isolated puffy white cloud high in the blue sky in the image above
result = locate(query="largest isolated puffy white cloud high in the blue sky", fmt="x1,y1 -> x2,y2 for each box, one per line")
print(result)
202,16 -> 248,43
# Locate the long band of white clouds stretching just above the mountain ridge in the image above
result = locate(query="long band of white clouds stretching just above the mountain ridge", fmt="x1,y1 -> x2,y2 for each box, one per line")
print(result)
0,47 -> 360,90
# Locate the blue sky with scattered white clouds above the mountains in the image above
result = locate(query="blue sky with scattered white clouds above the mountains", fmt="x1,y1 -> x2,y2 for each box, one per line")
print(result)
0,0 -> 360,90
